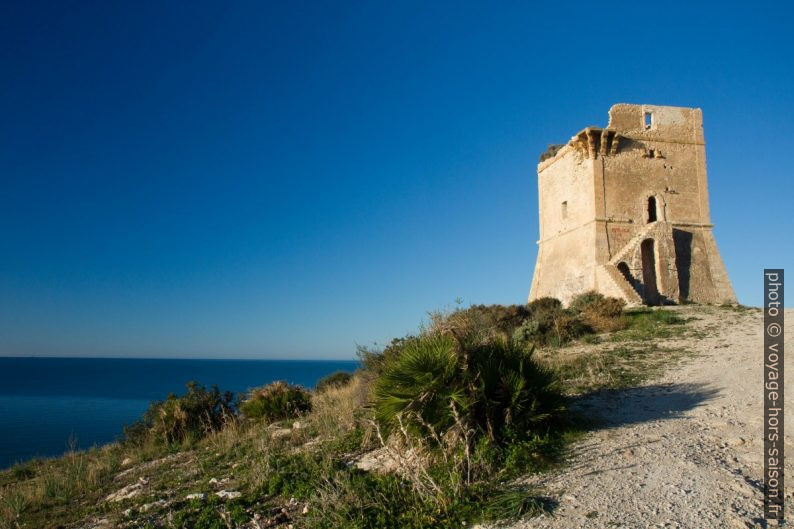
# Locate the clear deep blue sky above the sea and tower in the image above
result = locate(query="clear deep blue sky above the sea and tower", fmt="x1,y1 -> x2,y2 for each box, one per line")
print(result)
0,0 -> 794,358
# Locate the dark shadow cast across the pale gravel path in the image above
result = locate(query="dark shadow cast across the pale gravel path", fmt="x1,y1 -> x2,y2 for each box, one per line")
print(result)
571,383 -> 720,429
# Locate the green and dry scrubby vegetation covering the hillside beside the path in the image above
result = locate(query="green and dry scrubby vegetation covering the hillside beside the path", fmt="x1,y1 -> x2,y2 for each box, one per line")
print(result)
0,293 -> 696,529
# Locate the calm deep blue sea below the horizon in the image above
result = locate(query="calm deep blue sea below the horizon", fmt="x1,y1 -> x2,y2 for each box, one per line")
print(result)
0,358 -> 357,468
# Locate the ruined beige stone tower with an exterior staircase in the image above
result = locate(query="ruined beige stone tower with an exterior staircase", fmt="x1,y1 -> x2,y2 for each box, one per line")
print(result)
529,104 -> 736,305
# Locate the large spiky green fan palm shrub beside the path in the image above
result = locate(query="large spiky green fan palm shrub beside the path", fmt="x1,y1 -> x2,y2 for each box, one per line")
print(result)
374,334 -> 562,441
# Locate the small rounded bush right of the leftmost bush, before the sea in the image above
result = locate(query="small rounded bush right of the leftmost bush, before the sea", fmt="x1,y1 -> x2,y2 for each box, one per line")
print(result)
240,381 -> 312,422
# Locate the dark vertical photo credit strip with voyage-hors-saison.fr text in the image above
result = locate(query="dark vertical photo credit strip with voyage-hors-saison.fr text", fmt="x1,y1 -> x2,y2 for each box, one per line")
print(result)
764,268 -> 785,520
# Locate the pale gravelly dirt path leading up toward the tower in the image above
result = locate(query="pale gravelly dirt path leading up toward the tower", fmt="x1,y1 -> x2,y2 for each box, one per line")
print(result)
504,307 -> 794,529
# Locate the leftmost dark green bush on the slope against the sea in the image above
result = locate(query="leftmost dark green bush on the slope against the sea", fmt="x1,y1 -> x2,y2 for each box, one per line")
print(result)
124,382 -> 237,445
